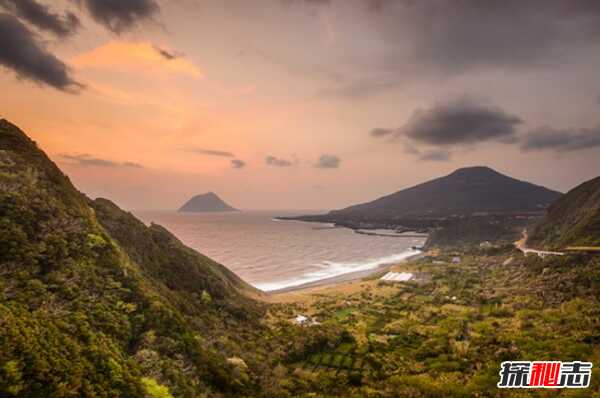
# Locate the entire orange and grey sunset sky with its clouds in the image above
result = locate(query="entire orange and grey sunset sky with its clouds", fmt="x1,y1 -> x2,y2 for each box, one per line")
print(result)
0,0 -> 600,209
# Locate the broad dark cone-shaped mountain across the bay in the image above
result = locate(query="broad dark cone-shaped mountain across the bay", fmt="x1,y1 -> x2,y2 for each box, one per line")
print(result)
329,167 -> 561,217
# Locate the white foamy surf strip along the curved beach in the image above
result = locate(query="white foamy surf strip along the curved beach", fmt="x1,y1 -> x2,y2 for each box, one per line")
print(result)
254,249 -> 421,292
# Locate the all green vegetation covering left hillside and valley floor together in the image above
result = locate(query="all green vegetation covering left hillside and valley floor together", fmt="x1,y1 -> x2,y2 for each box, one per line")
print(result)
0,121 -> 600,398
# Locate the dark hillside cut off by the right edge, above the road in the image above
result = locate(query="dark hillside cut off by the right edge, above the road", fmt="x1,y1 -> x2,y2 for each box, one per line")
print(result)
527,177 -> 600,249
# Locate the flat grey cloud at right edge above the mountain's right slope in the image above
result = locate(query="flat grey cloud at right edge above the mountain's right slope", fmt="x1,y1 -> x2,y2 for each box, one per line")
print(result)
521,127 -> 600,152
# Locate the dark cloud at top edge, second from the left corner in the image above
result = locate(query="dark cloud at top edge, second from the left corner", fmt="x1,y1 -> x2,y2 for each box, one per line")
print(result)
73,0 -> 160,33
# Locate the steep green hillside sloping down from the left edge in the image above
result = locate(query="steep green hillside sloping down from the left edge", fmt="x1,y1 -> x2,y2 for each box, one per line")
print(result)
0,120 -> 272,397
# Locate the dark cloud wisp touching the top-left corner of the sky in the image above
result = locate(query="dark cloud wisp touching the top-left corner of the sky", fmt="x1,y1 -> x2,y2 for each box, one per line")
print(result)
0,0 -> 80,37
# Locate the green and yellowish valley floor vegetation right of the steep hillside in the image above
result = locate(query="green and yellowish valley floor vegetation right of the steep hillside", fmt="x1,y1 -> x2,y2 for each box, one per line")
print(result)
270,246 -> 600,398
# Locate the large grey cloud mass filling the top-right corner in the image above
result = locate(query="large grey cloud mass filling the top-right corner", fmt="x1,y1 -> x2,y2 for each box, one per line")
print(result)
370,0 -> 600,72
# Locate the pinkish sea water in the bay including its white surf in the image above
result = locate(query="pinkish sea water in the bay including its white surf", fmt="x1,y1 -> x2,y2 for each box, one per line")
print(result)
134,211 -> 424,291
